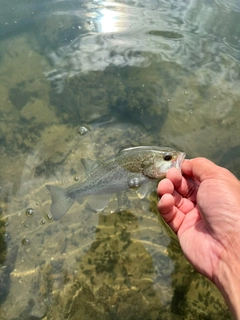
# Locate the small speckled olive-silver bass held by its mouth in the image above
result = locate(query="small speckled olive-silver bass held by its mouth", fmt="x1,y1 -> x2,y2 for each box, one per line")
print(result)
46,146 -> 185,221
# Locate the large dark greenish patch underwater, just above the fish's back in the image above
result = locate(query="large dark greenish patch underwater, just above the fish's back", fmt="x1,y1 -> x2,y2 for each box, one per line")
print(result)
51,63 -> 167,131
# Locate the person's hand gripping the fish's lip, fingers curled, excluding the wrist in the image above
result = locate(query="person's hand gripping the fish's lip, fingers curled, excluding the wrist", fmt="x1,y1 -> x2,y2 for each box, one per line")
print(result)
158,158 -> 240,280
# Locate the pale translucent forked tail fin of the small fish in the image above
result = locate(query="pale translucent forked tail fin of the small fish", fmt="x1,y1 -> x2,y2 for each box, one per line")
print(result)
46,185 -> 74,220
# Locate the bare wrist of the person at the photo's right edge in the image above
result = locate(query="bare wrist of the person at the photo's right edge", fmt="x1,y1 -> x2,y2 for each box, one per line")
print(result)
213,246 -> 240,319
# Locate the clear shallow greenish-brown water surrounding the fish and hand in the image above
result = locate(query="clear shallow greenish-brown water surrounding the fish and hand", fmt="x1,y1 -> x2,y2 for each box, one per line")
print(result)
0,0 -> 240,320
